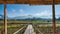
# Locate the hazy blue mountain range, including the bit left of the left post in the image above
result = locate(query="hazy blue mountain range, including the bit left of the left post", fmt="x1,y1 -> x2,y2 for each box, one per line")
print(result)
0,14 -> 50,20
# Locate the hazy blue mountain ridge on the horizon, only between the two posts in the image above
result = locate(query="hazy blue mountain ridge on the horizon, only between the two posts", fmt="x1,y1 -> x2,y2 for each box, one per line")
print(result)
8,15 -> 49,20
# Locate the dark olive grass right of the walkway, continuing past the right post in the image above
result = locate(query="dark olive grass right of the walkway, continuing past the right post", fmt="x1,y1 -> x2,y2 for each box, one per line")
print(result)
37,26 -> 60,34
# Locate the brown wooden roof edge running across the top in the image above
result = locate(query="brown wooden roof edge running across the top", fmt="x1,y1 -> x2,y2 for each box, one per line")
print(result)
0,0 -> 60,5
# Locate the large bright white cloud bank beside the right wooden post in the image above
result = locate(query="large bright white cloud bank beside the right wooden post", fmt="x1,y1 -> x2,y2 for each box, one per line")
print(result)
34,10 -> 52,18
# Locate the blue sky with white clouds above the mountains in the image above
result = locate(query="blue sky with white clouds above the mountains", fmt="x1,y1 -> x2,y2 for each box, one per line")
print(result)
0,4 -> 60,18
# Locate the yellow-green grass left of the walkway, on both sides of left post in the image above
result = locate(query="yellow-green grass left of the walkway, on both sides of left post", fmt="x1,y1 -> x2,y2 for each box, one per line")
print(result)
0,25 -> 24,34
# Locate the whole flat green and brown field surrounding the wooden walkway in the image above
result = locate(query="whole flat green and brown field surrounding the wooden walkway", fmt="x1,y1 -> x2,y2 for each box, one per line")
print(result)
0,20 -> 60,34
